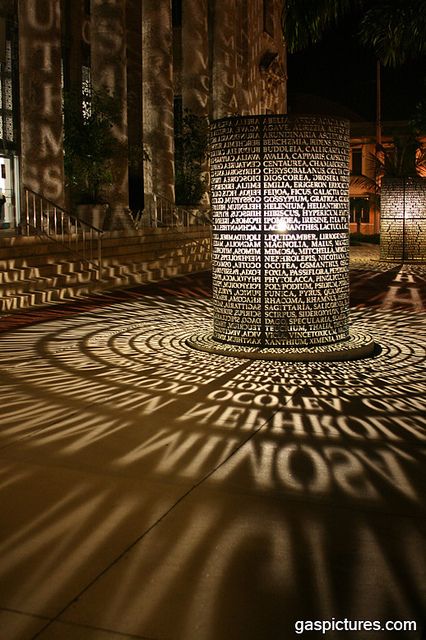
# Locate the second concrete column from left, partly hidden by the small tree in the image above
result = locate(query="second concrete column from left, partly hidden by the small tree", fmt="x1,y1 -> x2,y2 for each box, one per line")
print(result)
91,0 -> 129,211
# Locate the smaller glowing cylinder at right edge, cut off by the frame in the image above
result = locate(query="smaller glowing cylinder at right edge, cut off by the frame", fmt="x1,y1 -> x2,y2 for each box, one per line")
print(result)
380,177 -> 426,261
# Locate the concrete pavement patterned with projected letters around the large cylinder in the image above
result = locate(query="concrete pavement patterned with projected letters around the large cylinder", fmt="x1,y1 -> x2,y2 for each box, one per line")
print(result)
0,248 -> 426,640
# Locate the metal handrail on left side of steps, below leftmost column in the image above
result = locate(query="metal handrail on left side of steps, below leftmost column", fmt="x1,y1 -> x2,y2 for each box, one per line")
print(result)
24,187 -> 103,279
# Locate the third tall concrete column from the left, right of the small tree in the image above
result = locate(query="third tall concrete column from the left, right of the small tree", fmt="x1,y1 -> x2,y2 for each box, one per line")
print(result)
142,0 -> 174,201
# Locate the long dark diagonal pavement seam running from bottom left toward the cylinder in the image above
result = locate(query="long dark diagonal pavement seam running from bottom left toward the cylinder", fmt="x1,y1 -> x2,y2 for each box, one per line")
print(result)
31,390 -> 299,640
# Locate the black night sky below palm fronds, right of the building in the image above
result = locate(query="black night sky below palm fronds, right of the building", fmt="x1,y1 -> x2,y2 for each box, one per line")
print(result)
288,12 -> 426,121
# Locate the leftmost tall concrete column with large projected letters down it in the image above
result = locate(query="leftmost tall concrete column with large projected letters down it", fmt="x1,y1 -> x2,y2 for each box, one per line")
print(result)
18,0 -> 64,205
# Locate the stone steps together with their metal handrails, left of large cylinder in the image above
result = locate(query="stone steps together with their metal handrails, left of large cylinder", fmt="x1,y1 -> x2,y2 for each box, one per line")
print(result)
0,189 -> 210,315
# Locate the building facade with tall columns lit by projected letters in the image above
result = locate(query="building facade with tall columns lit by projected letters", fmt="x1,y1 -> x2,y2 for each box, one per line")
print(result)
0,0 -> 286,227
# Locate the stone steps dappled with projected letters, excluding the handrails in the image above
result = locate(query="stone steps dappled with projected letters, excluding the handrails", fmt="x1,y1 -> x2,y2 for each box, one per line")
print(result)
0,226 -> 210,322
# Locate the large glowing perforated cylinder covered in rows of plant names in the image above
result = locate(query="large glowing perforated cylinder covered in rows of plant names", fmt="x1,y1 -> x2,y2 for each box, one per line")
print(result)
211,116 -> 349,347
